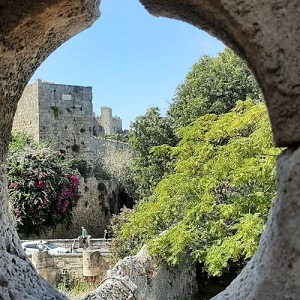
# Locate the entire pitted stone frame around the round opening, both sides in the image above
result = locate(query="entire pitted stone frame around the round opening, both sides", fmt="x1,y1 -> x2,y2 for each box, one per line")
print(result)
0,0 -> 300,299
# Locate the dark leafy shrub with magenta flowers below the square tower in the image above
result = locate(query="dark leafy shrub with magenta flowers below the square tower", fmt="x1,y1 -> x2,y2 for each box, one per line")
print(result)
7,138 -> 79,235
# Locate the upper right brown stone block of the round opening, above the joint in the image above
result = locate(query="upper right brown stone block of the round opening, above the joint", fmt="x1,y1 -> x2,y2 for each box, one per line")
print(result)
140,0 -> 300,146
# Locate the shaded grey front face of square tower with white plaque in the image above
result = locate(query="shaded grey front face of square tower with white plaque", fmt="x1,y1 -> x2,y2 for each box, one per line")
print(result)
39,78 -> 93,161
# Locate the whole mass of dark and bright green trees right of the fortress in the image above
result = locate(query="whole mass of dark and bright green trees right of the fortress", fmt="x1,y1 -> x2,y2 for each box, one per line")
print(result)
106,49 -> 280,275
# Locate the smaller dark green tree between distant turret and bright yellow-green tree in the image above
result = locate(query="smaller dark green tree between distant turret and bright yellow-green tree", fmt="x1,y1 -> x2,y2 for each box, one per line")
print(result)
129,107 -> 177,200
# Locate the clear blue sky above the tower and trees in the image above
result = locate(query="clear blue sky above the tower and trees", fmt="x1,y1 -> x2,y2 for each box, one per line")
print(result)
31,0 -> 224,129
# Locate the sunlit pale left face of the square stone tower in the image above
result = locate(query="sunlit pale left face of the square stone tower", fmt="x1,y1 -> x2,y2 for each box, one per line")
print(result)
12,81 -> 39,141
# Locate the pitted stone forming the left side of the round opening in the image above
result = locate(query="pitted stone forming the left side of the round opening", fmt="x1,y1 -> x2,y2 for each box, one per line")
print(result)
0,0 -> 99,300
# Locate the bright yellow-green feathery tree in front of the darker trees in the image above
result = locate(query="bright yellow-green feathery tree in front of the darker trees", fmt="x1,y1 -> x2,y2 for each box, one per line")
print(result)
111,100 -> 279,275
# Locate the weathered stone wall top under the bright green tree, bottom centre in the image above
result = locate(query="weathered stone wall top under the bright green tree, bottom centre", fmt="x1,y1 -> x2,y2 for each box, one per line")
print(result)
84,246 -> 198,300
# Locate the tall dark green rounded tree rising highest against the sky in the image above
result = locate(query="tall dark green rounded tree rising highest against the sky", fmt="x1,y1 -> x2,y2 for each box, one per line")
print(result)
168,48 -> 261,128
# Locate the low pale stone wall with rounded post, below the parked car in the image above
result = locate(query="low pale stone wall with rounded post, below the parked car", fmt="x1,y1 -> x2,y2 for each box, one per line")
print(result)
28,250 -> 108,285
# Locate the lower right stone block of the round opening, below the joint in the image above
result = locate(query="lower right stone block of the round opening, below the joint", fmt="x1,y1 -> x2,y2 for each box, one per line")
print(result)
213,148 -> 300,300
